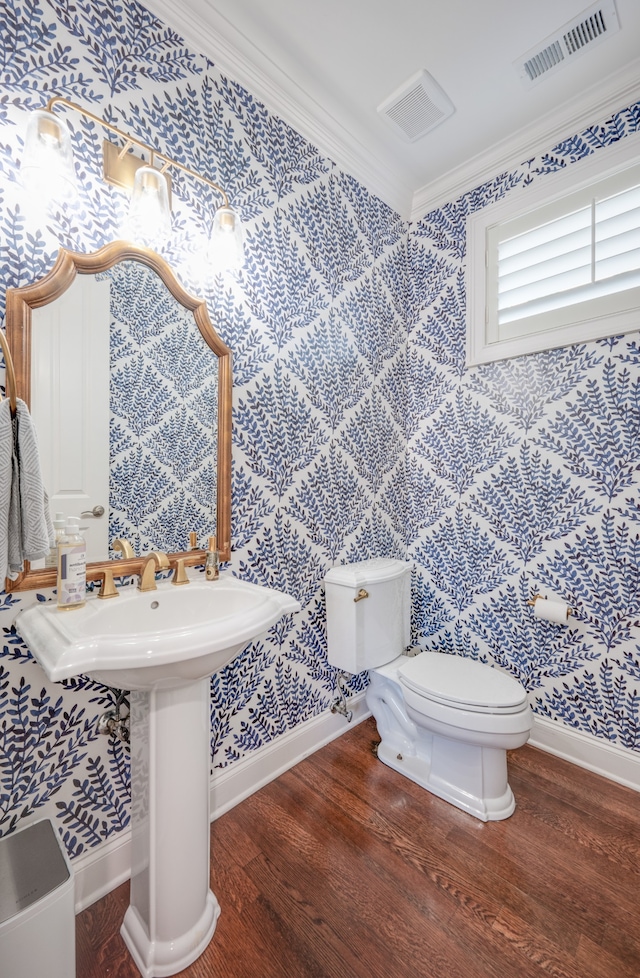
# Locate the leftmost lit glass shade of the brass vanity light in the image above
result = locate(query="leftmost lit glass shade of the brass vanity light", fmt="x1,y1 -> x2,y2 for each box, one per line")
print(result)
20,109 -> 77,203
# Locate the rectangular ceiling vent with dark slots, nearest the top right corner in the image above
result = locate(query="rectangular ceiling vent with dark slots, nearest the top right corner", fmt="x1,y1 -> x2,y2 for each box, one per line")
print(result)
514,0 -> 620,87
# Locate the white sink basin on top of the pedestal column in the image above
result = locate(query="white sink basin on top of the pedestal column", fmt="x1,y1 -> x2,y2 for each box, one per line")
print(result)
16,575 -> 300,690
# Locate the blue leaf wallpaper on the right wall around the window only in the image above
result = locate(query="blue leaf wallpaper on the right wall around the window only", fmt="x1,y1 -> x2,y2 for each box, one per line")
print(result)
404,103 -> 640,751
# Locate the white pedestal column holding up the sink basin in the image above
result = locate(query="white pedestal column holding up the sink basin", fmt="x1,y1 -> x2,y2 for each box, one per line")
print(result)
120,677 -> 220,978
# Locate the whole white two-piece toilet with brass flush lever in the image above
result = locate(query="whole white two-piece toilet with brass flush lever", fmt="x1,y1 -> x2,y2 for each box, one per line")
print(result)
324,557 -> 532,822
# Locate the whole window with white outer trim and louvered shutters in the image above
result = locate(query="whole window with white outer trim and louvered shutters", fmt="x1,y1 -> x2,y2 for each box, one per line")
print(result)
467,137 -> 640,364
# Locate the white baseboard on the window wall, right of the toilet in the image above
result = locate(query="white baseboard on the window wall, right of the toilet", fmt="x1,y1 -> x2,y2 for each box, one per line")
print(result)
529,716 -> 640,791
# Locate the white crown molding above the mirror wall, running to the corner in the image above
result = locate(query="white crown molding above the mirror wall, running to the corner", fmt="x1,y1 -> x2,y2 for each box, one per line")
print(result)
144,0 -> 413,219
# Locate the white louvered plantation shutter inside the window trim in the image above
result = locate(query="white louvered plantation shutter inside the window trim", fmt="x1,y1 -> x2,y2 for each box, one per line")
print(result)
486,165 -> 640,342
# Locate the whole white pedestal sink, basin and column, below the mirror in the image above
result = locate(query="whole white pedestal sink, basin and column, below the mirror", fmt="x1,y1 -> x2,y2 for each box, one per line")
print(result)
16,575 -> 300,978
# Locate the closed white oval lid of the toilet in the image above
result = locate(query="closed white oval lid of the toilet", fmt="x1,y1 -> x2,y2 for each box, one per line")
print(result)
398,652 -> 527,713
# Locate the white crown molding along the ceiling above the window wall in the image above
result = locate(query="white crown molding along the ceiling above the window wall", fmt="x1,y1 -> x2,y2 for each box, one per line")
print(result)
411,58 -> 640,221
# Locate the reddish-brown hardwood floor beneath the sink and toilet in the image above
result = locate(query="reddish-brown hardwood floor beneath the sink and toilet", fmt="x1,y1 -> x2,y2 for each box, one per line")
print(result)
76,720 -> 640,978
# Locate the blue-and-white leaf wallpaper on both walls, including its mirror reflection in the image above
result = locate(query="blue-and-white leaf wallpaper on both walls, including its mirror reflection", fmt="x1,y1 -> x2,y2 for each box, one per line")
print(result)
0,0 -> 640,857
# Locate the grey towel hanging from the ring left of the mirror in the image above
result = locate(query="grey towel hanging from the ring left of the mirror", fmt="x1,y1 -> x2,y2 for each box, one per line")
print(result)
0,399 -> 55,581
